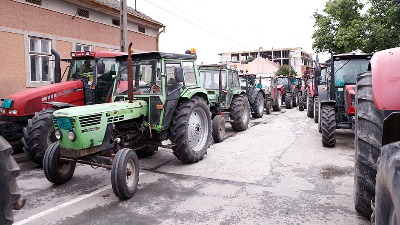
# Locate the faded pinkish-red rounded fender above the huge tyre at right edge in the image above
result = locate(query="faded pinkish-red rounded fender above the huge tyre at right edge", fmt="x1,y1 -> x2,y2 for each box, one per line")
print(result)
370,48 -> 400,110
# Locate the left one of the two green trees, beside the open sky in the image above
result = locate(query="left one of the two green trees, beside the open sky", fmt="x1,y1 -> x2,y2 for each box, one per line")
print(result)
312,0 -> 365,54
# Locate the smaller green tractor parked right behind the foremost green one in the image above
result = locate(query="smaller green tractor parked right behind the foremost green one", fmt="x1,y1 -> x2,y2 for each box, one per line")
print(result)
199,65 -> 250,143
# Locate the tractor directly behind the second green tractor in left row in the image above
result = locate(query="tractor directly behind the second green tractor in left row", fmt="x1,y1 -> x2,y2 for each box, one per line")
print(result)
241,74 -> 268,118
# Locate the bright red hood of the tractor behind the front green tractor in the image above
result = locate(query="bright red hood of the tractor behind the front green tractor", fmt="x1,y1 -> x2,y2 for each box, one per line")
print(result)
2,80 -> 84,116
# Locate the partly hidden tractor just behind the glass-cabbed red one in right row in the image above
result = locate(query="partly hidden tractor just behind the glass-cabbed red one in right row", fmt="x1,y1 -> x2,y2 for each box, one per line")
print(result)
306,63 -> 328,123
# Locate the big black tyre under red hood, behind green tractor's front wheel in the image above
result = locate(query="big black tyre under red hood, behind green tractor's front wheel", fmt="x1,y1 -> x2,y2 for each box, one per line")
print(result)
22,108 -> 57,166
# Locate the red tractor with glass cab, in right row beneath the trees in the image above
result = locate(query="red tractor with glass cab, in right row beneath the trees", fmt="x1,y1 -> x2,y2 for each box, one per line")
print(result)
314,54 -> 372,147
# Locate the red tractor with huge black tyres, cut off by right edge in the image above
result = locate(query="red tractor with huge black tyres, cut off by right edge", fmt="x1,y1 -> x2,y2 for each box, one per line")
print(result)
354,48 -> 400,224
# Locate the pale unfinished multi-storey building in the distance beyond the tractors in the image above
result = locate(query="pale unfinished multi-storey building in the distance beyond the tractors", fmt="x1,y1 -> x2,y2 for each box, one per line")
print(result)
219,47 -> 313,75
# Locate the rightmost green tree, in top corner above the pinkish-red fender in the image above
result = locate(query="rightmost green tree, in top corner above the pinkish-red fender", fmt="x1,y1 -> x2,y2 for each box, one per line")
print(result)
360,0 -> 400,52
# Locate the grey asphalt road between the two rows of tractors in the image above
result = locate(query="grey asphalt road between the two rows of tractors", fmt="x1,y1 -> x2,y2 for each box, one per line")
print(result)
14,109 -> 370,225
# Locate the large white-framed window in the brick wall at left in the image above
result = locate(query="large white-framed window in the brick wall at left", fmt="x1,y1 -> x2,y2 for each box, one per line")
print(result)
29,37 -> 51,81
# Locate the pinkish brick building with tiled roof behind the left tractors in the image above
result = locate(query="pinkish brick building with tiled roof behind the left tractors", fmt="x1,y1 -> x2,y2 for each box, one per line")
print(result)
0,0 -> 165,98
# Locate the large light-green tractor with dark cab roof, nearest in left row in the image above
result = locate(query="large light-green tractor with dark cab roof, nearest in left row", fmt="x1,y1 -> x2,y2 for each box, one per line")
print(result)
43,47 -> 211,199
